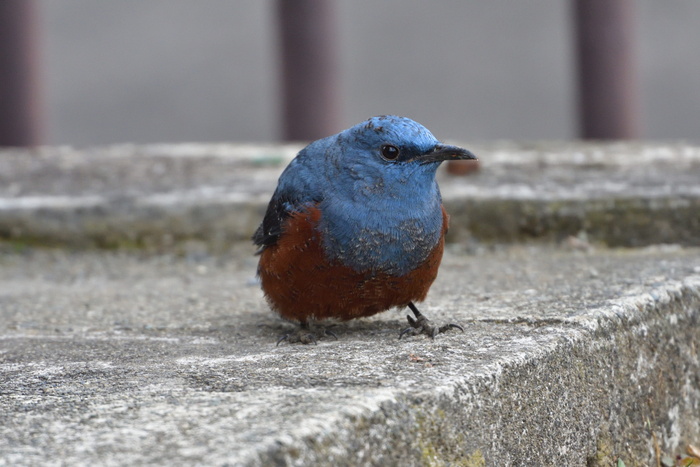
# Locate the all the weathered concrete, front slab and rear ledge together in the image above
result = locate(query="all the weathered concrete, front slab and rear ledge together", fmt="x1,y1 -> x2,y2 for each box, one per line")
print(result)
0,143 -> 700,467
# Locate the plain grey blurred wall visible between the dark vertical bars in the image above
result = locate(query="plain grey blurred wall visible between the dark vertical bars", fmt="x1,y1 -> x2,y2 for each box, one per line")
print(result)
39,0 -> 700,146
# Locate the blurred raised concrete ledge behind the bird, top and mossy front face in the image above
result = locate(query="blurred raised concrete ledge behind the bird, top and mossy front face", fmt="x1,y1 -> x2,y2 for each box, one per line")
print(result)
0,143 -> 700,251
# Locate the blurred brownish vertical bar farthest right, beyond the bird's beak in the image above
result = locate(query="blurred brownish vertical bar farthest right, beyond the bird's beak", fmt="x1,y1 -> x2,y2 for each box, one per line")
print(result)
574,0 -> 639,139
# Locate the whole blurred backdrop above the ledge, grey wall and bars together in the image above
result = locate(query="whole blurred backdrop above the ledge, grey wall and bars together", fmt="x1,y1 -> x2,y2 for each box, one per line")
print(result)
0,0 -> 700,146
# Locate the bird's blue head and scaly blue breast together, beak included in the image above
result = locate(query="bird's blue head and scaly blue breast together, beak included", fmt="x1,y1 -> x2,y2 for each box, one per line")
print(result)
308,115 -> 476,274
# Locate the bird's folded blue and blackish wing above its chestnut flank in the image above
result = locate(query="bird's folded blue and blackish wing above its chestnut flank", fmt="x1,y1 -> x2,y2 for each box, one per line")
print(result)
253,158 -> 321,253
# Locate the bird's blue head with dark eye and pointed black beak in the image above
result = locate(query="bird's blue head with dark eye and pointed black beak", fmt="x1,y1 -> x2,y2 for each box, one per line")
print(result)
327,115 -> 476,198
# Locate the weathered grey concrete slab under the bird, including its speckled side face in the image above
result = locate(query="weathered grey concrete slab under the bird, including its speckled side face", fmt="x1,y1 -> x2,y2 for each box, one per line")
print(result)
0,245 -> 700,466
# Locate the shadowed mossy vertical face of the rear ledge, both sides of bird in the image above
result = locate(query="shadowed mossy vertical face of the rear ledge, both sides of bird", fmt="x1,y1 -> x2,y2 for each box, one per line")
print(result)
0,197 -> 700,252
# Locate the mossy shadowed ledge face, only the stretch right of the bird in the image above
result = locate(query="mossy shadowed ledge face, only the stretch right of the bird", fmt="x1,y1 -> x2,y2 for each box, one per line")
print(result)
446,197 -> 700,247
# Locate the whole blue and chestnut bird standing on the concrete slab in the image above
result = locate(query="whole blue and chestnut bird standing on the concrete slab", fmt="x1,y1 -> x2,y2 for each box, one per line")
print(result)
252,115 -> 477,345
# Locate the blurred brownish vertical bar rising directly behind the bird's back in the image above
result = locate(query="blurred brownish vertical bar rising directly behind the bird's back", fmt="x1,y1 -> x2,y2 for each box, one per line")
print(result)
277,0 -> 340,140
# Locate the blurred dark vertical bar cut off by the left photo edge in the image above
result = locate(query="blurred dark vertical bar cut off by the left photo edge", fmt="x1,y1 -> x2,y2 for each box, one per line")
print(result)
0,0 -> 41,146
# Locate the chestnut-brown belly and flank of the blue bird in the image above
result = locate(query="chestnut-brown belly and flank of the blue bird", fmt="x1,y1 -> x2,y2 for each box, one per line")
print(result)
258,208 -> 447,322
